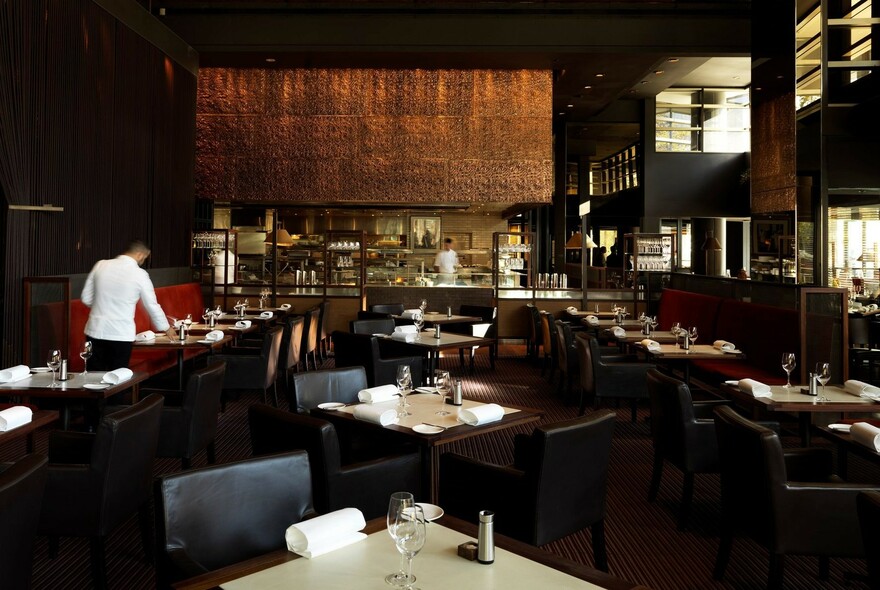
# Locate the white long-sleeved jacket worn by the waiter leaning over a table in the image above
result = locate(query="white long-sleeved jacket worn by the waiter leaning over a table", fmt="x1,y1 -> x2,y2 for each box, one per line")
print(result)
81,254 -> 170,342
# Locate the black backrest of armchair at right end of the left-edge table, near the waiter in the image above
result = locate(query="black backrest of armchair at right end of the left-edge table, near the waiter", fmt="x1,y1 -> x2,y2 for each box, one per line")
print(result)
181,362 -> 226,457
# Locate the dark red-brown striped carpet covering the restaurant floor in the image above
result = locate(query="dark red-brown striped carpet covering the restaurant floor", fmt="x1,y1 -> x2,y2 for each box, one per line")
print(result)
10,347 -> 880,590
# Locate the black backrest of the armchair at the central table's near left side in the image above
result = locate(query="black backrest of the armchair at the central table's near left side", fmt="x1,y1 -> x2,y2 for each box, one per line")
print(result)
248,404 -> 342,513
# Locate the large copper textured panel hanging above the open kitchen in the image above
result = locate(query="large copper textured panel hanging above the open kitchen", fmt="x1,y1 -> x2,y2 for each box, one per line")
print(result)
196,68 -> 552,203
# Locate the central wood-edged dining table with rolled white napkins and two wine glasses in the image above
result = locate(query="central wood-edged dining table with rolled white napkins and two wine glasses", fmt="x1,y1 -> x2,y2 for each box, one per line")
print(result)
311,394 -> 543,502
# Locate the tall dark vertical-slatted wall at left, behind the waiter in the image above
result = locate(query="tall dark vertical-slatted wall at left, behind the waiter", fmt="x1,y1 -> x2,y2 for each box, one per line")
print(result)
0,0 -> 196,366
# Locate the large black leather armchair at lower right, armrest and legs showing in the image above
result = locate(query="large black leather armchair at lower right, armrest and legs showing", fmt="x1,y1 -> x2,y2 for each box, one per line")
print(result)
714,406 -> 877,589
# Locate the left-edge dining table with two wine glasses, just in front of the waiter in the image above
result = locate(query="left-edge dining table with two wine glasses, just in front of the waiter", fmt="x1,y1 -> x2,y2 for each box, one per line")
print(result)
0,367 -> 149,430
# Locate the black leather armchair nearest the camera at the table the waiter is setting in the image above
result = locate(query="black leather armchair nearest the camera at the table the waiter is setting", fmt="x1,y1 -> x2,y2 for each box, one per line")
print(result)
211,326 -> 283,406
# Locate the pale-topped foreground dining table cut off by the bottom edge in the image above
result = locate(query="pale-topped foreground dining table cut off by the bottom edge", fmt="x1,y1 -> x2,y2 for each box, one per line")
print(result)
173,515 -> 647,590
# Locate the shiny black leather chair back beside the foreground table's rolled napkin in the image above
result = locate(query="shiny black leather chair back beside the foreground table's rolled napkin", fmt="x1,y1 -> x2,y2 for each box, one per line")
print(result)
154,451 -> 315,589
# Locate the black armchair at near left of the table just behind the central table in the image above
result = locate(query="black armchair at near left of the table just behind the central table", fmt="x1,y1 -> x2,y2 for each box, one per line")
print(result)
333,331 -> 424,387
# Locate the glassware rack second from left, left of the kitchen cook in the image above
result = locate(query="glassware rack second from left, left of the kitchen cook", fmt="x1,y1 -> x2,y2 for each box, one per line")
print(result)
324,231 -> 366,297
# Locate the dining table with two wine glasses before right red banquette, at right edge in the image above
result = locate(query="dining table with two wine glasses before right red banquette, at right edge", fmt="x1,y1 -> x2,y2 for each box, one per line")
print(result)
720,381 -> 880,447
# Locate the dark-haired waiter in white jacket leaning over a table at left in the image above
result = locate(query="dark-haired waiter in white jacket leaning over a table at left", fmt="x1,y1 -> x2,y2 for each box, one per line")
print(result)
81,240 -> 177,371
